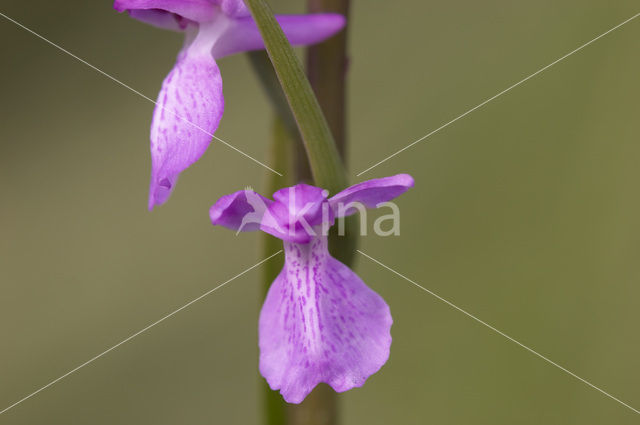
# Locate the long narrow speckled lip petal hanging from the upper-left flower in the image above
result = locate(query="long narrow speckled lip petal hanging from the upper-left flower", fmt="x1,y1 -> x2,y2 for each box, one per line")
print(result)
149,25 -> 224,209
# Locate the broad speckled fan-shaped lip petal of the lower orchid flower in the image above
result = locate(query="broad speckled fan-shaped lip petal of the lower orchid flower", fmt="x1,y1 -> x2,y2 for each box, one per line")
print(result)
259,238 -> 392,403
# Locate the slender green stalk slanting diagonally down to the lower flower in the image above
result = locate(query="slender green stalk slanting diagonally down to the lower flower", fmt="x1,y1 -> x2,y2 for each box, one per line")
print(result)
246,0 -> 347,194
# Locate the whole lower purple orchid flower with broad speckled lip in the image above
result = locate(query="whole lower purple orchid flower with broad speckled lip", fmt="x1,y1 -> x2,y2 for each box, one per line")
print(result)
209,174 -> 413,403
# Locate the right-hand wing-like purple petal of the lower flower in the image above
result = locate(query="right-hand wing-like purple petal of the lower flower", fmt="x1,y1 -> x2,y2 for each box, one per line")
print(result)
329,174 -> 413,216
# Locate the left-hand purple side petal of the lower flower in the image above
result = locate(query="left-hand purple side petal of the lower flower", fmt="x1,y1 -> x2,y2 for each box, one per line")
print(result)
209,189 -> 273,232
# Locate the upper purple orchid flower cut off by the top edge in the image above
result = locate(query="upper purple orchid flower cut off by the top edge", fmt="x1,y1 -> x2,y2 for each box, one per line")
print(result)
113,0 -> 345,210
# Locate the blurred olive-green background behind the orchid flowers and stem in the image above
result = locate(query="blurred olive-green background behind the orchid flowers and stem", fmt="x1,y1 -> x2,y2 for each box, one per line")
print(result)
0,0 -> 640,425
